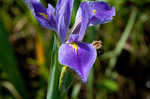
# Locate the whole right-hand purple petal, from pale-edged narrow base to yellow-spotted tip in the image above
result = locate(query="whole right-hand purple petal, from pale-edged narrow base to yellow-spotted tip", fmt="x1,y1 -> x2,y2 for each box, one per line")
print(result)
68,1 -> 115,42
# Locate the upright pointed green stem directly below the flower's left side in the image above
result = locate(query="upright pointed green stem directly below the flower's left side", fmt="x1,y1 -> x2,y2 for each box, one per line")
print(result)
47,35 -> 59,99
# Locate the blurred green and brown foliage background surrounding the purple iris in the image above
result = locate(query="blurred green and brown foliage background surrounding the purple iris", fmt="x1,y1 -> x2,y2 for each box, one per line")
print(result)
0,0 -> 150,99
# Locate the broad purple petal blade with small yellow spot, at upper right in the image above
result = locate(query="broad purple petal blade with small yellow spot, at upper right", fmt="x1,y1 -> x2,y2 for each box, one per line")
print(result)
86,1 -> 115,26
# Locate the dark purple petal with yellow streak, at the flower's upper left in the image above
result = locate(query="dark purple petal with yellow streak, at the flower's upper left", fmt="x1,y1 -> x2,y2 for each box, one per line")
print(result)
26,0 -> 56,30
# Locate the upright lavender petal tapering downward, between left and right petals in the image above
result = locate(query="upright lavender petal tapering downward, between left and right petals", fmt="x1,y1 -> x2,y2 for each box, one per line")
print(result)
56,0 -> 74,42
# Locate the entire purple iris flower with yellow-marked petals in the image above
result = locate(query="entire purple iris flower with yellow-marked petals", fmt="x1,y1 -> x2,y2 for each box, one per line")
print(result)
27,0 -> 115,82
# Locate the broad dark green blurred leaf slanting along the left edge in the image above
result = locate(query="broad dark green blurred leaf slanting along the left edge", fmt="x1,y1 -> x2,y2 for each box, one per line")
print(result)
0,21 -> 28,99
